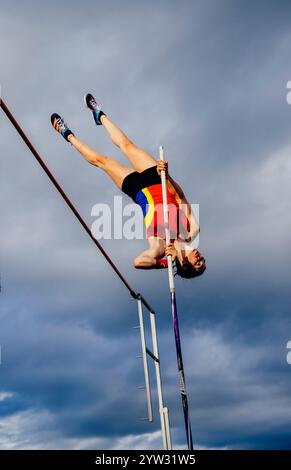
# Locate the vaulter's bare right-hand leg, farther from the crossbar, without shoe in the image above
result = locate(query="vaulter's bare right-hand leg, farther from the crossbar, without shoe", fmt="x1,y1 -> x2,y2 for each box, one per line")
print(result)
100,114 -> 157,172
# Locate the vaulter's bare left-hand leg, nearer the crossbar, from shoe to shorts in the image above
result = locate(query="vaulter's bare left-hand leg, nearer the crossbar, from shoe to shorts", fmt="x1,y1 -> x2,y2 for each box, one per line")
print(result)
68,134 -> 134,189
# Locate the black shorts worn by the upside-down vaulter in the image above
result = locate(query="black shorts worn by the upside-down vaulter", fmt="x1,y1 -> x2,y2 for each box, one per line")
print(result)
121,165 -> 161,200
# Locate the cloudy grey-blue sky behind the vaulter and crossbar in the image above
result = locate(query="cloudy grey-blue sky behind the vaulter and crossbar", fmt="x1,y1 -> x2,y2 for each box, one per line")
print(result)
0,0 -> 291,449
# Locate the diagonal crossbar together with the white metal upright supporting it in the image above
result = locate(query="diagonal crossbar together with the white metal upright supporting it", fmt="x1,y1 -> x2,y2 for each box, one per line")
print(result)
0,98 -> 172,450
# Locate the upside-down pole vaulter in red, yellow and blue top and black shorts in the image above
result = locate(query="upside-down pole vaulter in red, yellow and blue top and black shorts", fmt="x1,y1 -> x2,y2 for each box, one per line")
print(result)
51,94 -> 206,279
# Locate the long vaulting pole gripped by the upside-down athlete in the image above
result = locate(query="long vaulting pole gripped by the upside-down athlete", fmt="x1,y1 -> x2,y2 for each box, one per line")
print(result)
160,145 -> 193,450
